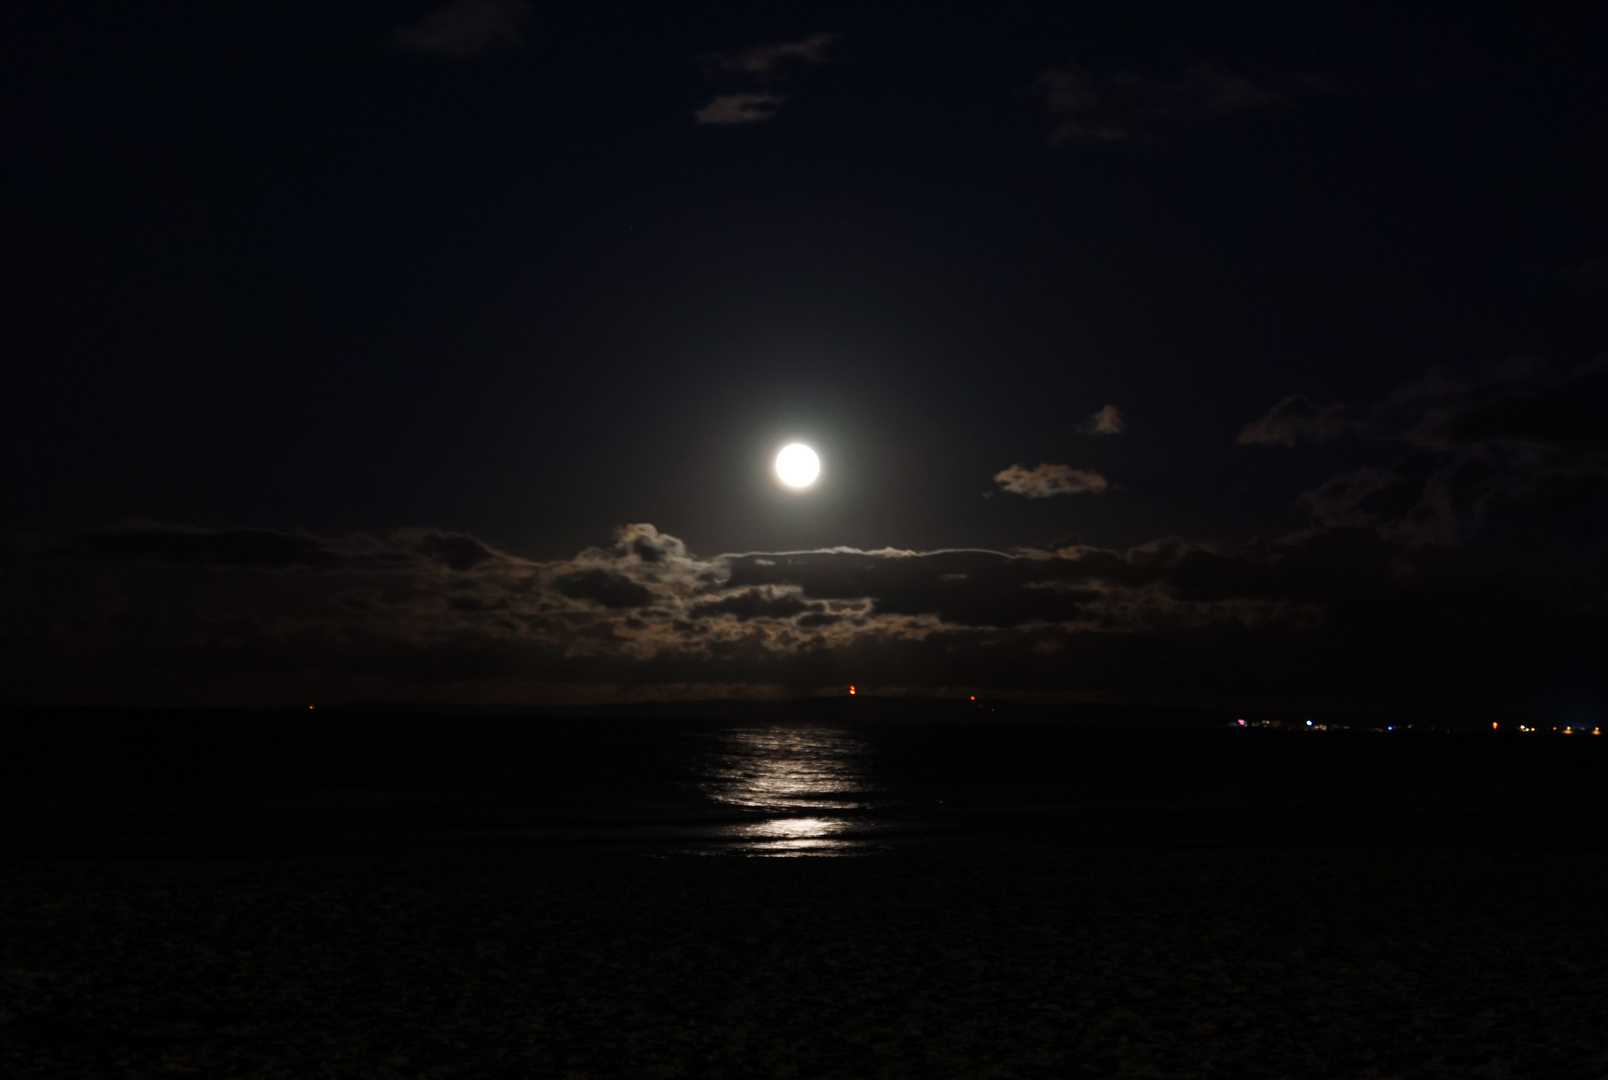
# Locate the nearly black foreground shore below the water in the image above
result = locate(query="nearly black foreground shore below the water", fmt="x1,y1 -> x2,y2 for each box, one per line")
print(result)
0,852 -> 1608,1080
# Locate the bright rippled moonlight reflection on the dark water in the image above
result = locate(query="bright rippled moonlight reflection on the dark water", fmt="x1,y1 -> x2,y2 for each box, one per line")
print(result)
699,728 -> 878,855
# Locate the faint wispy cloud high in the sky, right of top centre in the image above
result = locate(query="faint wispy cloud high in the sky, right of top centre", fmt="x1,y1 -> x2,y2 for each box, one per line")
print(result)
1034,64 -> 1293,143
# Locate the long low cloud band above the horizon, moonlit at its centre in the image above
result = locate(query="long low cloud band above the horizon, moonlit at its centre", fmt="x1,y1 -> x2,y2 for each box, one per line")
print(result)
0,501 -> 1600,707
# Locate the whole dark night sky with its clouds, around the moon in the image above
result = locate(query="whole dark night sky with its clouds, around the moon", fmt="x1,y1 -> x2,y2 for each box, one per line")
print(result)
0,0 -> 1608,722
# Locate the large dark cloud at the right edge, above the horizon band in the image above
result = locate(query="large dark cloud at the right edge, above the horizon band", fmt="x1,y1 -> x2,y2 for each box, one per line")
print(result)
1241,358 -> 1608,609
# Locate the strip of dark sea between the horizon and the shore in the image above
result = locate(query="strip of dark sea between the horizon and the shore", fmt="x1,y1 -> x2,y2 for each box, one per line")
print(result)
0,712 -> 1608,857
